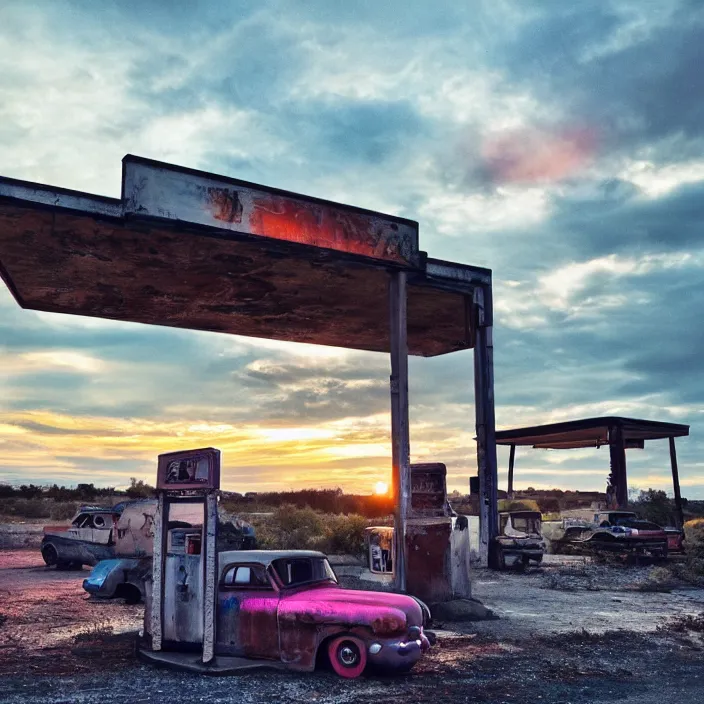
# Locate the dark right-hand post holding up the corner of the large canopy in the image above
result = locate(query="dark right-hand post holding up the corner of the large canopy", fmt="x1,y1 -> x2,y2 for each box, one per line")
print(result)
474,287 -> 499,565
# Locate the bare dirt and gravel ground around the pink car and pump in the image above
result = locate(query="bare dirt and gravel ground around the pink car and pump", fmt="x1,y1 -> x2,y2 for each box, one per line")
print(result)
0,551 -> 704,704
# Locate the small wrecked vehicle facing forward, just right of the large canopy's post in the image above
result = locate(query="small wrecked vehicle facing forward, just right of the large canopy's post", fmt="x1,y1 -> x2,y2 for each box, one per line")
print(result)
492,511 -> 545,569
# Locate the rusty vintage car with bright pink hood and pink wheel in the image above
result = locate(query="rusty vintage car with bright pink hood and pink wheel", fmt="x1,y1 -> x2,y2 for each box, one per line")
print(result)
145,550 -> 430,678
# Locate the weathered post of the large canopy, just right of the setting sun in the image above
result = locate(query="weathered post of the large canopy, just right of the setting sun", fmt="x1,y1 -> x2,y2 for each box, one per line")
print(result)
389,271 -> 411,591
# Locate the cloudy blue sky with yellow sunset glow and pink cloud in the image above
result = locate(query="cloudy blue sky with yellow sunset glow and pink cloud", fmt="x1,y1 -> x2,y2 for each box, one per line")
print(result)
0,0 -> 704,498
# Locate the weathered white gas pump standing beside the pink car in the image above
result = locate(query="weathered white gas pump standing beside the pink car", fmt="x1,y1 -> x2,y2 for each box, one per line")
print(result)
144,448 -> 220,663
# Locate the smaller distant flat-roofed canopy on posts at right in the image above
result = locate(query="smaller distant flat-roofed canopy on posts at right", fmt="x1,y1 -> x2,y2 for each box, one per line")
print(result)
496,416 -> 689,525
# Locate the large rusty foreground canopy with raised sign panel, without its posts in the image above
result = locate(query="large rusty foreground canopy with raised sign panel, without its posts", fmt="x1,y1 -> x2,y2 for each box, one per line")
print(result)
0,155 -> 491,357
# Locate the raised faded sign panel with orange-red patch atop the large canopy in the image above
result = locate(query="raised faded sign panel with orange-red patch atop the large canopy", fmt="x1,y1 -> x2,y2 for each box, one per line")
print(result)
122,156 -> 418,264
